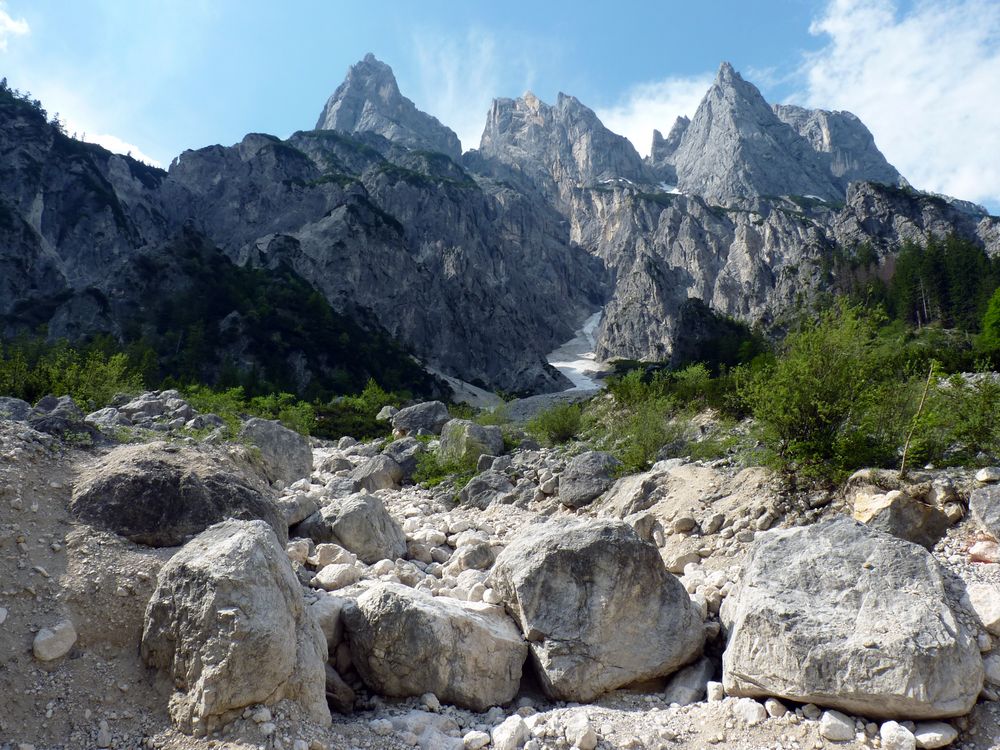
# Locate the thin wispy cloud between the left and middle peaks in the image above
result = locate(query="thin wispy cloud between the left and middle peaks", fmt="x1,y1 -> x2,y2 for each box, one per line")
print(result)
403,29 -> 534,151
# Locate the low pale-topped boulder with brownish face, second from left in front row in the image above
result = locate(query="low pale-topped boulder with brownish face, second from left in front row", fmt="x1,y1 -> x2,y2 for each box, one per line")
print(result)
342,583 -> 528,711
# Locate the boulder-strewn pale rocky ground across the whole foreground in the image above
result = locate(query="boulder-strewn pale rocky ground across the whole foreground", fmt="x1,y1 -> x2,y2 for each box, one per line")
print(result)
0,394 -> 1000,750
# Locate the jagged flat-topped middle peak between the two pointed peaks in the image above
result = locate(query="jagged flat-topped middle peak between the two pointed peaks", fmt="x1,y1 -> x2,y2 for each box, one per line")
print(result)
476,92 -> 647,205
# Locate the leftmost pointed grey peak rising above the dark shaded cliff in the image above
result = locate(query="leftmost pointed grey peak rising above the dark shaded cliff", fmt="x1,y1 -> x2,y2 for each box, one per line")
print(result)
316,52 -> 462,159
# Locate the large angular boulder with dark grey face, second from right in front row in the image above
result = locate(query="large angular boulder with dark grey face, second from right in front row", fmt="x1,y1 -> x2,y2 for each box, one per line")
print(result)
489,518 -> 704,701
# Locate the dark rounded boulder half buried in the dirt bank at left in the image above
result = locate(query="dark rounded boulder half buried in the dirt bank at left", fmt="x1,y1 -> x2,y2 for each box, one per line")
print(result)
70,442 -> 288,547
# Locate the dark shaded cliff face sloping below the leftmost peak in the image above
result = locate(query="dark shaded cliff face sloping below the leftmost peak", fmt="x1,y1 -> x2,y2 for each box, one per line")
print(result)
169,126 -> 605,391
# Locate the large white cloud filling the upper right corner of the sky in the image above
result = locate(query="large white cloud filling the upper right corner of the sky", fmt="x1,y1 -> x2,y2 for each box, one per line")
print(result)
802,0 -> 1000,212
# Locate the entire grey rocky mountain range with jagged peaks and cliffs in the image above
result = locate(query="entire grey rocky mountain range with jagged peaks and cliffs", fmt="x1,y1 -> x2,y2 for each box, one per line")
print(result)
0,55 -> 1000,391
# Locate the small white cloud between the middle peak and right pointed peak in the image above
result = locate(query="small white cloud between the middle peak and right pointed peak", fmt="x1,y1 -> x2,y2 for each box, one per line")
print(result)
597,73 -> 714,156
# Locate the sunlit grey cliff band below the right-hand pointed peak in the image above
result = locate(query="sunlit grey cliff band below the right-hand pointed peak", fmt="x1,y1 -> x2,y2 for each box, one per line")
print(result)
571,183 -> 1000,360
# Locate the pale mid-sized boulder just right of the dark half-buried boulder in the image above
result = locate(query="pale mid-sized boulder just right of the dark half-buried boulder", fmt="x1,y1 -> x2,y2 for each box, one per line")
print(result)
295,492 -> 406,565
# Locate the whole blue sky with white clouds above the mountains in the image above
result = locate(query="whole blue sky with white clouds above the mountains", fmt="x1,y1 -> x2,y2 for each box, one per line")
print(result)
0,0 -> 1000,214
